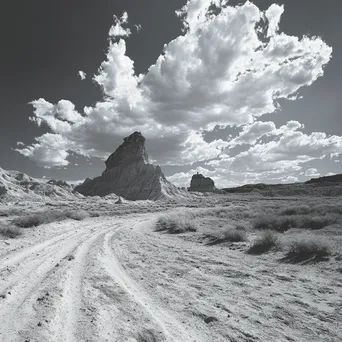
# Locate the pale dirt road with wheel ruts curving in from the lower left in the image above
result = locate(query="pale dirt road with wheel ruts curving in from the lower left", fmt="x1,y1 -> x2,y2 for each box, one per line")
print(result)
0,215 -> 206,342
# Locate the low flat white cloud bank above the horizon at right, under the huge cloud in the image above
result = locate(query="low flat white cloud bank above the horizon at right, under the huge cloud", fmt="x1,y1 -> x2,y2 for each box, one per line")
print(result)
202,121 -> 342,184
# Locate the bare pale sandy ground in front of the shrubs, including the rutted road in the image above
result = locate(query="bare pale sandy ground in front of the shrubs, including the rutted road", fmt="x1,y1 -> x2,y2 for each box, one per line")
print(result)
0,208 -> 342,342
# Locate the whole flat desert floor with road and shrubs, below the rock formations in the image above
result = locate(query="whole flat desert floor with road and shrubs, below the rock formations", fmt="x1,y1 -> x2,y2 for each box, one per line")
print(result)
0,194 -> 342,342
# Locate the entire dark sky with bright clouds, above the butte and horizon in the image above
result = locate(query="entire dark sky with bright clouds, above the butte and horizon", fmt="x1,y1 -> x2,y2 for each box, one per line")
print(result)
0,0 -> 342,188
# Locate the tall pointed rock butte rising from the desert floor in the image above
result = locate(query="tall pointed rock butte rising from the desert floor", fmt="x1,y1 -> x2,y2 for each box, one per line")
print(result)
75,132 -> 179,200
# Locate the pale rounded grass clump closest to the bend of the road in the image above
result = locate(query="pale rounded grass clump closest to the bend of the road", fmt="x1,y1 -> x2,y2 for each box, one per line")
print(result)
155,212 -> 197,234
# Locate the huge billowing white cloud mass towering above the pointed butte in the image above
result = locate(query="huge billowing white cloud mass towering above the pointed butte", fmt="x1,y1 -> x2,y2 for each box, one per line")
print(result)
17,0 -> 334,184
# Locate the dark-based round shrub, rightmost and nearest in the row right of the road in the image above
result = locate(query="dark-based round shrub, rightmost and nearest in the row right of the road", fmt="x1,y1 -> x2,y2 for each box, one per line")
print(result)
286,238 -> 331,262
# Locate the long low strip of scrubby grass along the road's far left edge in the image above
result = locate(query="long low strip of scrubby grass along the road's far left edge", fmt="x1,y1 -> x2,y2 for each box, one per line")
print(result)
12,209 -> 89,228
